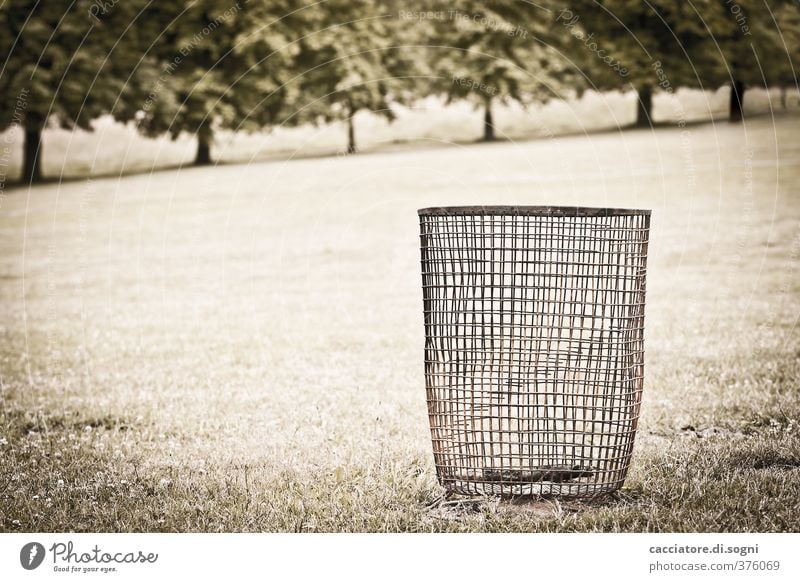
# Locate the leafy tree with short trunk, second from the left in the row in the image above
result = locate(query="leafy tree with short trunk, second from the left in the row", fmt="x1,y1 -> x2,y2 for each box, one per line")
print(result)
138,0 -> 304,165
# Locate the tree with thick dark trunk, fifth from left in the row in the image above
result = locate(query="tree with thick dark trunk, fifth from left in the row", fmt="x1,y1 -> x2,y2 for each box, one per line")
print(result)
556,0 -> 720,126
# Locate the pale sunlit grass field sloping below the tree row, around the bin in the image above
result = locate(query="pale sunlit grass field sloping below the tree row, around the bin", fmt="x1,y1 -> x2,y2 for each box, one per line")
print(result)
0,115 -> 800,531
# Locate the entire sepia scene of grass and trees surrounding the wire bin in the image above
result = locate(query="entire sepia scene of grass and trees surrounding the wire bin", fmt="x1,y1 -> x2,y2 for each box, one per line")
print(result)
0,0 -> 800,532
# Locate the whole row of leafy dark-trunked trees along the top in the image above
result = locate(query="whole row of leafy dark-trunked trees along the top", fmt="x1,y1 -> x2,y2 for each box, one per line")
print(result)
0,0 -> 800,182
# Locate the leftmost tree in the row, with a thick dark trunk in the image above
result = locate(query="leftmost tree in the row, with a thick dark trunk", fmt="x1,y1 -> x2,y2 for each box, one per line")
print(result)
0,0 -> 152,182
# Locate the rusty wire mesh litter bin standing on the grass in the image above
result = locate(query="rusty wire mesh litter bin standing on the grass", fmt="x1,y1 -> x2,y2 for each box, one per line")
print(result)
419,206 -> 650,497
